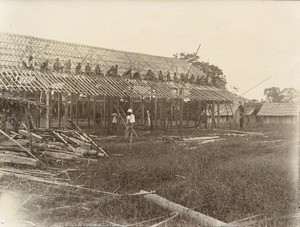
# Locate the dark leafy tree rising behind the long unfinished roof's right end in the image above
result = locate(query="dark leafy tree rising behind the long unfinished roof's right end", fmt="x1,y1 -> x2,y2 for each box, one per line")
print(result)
173,53 -> 227,89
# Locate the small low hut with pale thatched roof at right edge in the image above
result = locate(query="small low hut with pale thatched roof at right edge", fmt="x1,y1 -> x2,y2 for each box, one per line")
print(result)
257,103 -> 299,124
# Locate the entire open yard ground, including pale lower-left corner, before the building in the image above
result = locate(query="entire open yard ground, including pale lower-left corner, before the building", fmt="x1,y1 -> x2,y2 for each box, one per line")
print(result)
0,123 -> 299,226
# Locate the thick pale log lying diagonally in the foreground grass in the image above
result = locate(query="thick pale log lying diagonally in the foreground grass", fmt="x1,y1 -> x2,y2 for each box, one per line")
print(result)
140,190 -> 226,226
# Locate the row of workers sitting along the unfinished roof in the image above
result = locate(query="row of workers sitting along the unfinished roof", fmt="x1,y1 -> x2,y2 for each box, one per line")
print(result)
22,55 -> 222,85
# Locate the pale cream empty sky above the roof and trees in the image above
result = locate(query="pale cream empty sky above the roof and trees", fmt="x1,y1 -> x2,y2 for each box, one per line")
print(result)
0,0 -> 300,99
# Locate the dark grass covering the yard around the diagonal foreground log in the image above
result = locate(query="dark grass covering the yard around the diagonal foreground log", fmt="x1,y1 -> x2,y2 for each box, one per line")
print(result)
3,123 -> 298,226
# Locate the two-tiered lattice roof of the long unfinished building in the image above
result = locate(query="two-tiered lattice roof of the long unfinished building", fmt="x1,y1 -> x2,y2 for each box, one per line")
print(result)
0,33 -> 233,102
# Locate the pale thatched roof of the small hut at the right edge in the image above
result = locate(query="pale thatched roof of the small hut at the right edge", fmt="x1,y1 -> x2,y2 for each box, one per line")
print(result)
257,103 -> 300,116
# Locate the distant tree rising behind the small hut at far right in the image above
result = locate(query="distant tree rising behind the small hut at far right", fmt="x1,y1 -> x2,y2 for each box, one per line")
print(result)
264,87 -> 297,102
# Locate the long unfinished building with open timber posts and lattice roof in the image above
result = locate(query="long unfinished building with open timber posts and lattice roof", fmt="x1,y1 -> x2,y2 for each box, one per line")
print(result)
0,33 -> 234,130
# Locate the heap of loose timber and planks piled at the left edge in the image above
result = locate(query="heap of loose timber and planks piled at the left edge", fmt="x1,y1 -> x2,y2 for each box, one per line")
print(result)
0,121 -> 108,166
